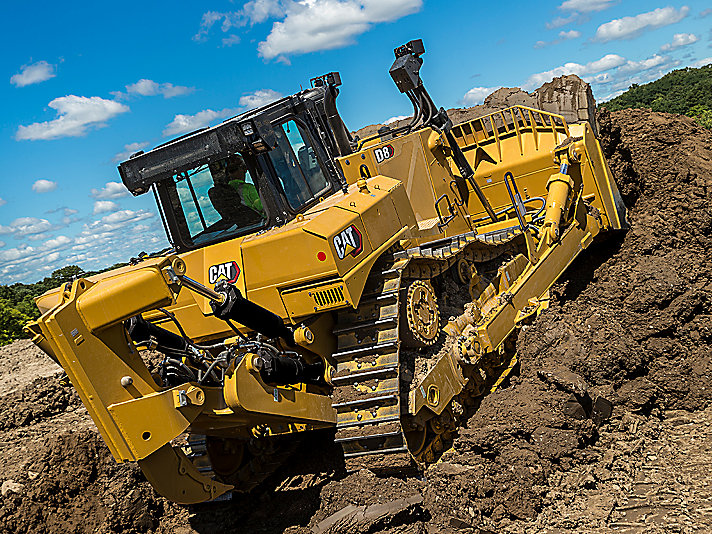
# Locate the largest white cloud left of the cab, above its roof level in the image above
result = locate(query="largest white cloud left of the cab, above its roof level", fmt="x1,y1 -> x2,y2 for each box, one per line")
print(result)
15,95 -> 129,140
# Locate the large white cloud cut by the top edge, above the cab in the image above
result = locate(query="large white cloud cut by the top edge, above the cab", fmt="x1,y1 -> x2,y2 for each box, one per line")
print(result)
257,0 -> 423,61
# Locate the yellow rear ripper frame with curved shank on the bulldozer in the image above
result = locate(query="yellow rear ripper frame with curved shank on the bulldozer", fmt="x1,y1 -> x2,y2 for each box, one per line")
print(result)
31,257 -> 230,503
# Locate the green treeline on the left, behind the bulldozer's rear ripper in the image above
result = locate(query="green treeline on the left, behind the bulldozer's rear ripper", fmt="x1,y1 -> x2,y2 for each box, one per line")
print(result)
0,263 -> 126,345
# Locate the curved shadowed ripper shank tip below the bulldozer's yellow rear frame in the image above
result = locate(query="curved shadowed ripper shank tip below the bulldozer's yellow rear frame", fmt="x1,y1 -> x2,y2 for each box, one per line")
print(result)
138,443 -> 233,504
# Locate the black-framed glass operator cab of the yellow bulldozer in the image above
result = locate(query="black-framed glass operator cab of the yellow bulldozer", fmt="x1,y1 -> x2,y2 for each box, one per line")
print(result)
119,74 -> 356,252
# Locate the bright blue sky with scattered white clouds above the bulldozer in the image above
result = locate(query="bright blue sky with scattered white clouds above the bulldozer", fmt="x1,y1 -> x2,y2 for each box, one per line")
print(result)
0,0 -> 712,284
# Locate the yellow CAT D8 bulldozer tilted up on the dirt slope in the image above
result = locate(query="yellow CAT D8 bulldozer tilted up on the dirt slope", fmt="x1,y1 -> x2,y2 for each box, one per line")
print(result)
27,40 -> 627,503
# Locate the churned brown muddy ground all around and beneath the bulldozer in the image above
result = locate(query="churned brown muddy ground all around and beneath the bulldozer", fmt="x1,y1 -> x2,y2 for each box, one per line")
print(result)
0,110 -> 712,534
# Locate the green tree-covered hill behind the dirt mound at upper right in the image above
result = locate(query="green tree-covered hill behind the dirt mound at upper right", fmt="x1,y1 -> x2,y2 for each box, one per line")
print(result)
601,65 -> 712,129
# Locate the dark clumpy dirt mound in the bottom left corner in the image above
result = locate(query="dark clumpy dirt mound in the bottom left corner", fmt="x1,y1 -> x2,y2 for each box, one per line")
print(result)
0,431 -> 163,533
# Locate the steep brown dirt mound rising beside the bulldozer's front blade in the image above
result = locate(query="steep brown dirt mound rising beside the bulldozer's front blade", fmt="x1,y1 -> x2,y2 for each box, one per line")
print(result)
518,110 -> 712,411
